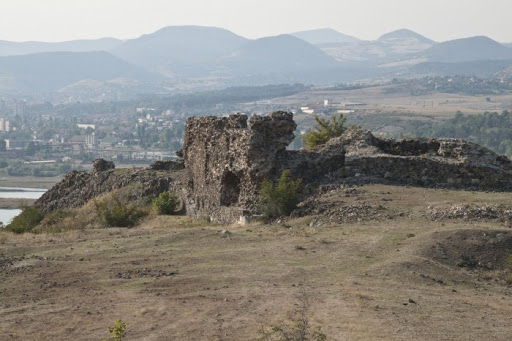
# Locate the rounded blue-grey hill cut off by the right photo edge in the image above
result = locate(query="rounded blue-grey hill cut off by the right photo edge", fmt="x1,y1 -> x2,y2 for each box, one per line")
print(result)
424,36 -> 512,63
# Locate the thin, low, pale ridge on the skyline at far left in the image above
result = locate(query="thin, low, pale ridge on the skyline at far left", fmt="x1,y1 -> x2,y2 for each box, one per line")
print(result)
0,38 -> 123,56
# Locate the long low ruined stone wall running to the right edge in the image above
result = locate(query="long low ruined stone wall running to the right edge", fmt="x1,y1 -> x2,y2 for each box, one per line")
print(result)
340,131 -> 512,191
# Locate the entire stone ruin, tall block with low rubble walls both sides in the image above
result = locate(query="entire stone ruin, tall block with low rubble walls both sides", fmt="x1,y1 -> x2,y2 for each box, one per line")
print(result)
35,111 -> 512,224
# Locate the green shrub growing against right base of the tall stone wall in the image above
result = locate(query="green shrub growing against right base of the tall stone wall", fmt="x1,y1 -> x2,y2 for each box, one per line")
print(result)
260,169 -> 302,219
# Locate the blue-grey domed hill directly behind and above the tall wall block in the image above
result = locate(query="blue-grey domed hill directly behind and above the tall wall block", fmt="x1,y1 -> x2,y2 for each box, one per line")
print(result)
222,34 -> 337,75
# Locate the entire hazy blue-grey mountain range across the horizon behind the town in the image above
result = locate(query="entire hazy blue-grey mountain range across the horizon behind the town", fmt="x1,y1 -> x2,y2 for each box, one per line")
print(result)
0,26 -> 512,96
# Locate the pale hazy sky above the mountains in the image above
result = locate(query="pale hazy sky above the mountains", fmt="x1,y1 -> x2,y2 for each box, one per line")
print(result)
0,0 -> 512,42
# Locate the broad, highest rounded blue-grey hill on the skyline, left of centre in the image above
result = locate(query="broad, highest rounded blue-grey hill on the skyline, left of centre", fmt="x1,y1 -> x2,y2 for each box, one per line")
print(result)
112,26 -> 247,72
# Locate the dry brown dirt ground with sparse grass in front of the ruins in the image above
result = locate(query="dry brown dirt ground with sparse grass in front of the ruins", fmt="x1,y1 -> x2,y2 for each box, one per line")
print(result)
0,185 -> 512,340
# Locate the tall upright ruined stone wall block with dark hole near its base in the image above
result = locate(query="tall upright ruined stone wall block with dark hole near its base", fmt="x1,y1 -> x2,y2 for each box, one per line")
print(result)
183,112 -> 296,223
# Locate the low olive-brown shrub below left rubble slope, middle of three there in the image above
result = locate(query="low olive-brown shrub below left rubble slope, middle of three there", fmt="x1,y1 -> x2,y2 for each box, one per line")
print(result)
94,196 -> 147,227
